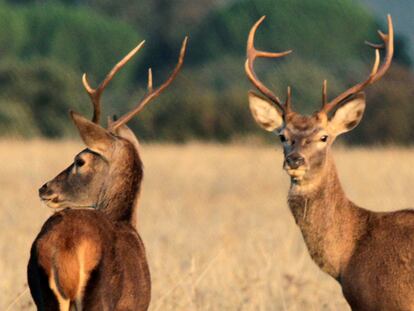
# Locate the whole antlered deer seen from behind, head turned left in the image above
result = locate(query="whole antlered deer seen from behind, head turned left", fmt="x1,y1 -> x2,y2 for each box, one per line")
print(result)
28,38 -> 187,311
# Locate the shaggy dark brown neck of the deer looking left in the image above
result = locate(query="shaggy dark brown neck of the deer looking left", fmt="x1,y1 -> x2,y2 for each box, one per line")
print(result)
98,144 -> 143,226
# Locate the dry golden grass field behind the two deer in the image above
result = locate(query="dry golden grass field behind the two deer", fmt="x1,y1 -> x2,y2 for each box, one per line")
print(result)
0,141 -> 414,311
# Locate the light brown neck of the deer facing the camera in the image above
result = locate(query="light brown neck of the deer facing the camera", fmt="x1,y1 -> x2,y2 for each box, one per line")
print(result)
288,154 -> 363,279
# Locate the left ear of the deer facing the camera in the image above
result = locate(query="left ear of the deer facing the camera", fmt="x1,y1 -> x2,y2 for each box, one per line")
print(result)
249,91 -> 284,132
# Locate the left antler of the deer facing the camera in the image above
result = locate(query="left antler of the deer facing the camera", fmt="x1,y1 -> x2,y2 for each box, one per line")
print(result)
245,16 -> 292,113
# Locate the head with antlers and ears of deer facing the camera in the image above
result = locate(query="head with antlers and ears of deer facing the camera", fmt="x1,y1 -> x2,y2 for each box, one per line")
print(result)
245,15 -> 394,185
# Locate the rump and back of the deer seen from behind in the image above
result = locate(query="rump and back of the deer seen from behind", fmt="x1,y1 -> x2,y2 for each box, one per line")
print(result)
28,209 -> 151,310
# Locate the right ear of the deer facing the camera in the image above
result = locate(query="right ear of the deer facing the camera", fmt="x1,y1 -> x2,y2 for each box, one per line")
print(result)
329,93 -> 365,135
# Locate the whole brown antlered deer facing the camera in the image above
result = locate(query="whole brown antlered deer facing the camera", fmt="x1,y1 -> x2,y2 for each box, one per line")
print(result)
245,16 -> 414,311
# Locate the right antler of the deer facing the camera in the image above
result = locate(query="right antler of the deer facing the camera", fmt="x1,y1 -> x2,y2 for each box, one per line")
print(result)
321,14 -> 394,113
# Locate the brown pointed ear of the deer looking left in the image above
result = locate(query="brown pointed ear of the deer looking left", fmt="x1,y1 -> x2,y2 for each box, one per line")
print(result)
70,111 -> 114,153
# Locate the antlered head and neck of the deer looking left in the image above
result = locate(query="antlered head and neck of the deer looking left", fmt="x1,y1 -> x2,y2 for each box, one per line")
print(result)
39,38 -> 187,220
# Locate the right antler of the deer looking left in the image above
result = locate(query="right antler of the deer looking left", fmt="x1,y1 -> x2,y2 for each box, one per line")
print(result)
110,37 -> 188,131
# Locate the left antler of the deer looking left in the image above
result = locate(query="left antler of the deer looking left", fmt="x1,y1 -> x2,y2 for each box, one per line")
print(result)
82,40 -> 145,123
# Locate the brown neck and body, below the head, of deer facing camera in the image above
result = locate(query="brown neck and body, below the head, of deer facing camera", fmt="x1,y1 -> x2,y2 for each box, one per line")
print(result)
288,154 -> 414,311
